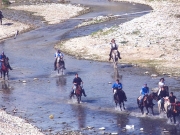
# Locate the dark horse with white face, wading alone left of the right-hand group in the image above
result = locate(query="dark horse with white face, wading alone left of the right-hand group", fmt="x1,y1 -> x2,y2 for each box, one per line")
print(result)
114,89 -> 127,111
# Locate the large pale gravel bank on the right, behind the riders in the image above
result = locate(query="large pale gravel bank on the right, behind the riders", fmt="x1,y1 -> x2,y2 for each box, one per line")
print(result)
56,0 -> 180,76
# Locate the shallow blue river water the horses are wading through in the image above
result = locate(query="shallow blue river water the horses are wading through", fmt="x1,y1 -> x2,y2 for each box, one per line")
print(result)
0,1 -> 180,135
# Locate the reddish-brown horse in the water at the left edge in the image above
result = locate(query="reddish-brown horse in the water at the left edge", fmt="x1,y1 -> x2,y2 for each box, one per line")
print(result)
1,57 -> 9,80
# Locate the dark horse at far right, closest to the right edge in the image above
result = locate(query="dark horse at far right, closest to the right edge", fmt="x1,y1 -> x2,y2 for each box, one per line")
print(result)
164,101 -> 180,124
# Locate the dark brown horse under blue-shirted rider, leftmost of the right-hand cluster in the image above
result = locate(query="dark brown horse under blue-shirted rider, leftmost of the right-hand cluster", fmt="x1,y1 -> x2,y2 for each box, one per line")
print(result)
137,92 -> 158,115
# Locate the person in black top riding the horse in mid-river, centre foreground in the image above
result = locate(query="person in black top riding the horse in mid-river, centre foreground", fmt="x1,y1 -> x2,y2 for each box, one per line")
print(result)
71,73 -> 87,97
